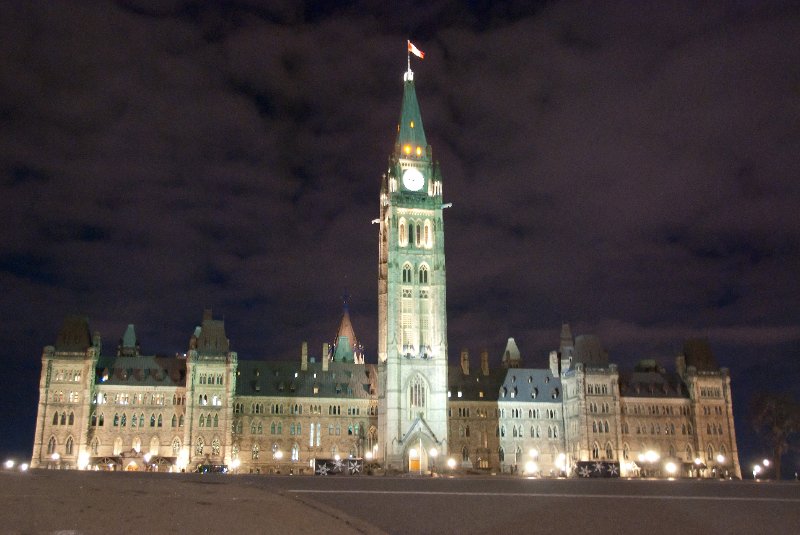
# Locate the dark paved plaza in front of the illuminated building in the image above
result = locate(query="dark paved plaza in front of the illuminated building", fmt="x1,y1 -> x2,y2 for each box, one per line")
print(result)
0,470 -> 800,535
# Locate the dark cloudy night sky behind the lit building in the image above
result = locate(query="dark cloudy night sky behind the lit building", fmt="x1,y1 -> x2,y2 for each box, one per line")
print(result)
0,0 -> 800,478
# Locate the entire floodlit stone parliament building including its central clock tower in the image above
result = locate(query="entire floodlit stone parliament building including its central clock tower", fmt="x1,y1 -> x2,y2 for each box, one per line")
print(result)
31,61 -> 741,478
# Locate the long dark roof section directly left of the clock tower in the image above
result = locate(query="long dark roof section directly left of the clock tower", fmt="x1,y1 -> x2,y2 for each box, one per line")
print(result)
236,360 -> 378,399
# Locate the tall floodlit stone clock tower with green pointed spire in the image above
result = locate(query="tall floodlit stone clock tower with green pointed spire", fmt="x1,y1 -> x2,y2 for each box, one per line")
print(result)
378,63 -> 448,472
